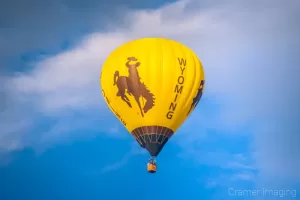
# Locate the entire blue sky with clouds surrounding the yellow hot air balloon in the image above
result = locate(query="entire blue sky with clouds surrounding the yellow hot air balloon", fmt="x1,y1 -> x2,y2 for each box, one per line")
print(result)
0,0 -> 300,200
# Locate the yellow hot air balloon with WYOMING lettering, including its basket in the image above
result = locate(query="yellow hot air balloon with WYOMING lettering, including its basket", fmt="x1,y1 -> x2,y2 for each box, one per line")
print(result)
100,38 -> 205,173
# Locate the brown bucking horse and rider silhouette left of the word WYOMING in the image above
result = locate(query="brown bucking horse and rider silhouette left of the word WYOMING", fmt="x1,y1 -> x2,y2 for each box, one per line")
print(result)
114,57 -> 155,117
